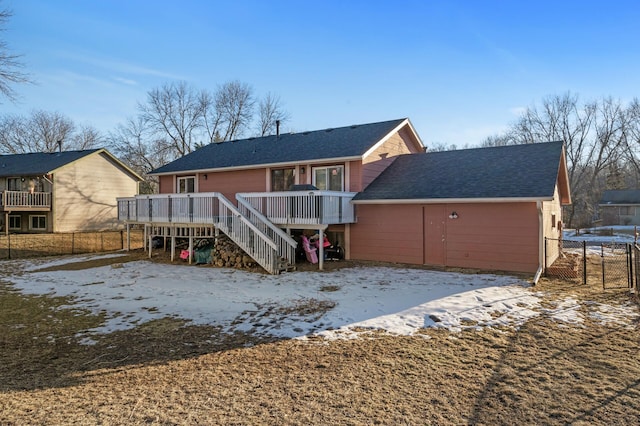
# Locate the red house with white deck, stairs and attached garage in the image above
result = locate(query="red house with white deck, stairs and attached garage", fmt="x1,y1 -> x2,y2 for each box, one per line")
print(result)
119,119 -> 570,273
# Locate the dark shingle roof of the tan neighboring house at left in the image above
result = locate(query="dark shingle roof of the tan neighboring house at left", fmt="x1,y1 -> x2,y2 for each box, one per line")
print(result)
0,149 -> 100,177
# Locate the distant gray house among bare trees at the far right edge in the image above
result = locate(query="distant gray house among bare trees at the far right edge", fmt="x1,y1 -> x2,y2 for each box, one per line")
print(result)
599,189 -> 640,226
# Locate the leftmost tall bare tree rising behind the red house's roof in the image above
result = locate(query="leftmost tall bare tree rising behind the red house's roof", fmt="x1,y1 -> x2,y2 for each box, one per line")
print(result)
138,82 -> 209,158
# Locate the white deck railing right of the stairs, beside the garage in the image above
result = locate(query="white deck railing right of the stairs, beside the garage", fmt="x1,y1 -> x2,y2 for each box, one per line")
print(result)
236,191 -> 356,226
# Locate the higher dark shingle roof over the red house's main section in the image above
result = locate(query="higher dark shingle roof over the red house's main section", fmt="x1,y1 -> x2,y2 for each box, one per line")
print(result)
152,119 -> 405,174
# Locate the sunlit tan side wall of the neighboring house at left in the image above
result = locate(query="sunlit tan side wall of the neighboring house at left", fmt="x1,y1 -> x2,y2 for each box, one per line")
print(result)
52,154 -> 138,232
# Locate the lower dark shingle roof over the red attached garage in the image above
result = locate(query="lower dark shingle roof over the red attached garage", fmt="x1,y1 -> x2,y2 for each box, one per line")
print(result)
354,142 -> 562,201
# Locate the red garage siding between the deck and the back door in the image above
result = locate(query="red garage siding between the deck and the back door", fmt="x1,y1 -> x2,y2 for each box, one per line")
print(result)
350,205 -> 423,264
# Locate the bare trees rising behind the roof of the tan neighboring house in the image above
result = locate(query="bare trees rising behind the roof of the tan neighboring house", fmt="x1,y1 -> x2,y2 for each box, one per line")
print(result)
0,110 -> 103,154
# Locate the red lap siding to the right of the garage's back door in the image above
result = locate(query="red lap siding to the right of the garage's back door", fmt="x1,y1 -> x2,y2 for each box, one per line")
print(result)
446,203 -> 539,272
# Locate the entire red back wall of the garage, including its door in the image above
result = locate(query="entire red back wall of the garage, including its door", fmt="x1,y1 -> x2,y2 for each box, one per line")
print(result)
350,203 -> 539,272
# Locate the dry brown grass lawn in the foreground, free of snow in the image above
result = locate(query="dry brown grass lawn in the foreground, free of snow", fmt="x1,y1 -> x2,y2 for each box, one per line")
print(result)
0,258 -> 640,425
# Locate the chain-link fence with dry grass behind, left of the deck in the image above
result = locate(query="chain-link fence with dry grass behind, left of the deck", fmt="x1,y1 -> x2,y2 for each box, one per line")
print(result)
0,229 -> 143,259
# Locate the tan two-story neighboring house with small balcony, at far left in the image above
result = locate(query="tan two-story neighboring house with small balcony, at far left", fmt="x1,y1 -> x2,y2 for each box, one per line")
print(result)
0,149 -> 142,233
